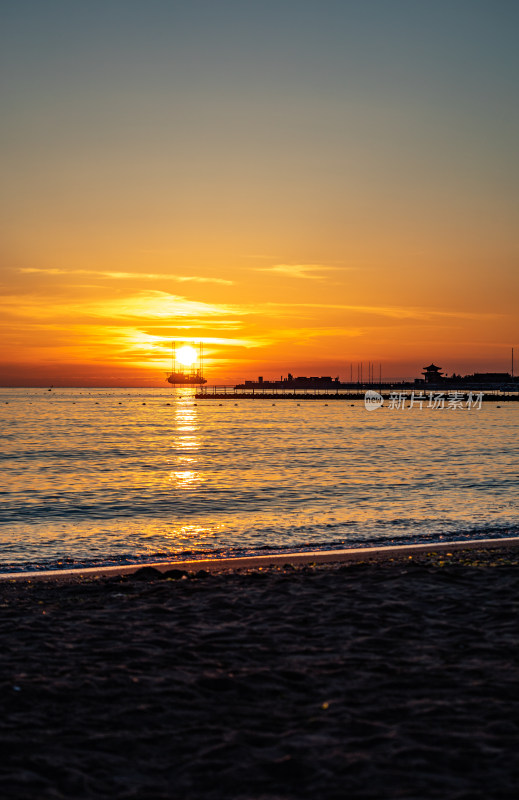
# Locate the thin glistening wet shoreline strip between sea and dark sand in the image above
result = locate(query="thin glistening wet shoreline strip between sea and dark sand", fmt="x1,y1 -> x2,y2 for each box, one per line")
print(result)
0,536 -> 519,583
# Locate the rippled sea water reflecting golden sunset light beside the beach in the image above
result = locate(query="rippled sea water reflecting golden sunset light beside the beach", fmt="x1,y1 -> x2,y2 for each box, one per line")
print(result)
0,389 -> 519,572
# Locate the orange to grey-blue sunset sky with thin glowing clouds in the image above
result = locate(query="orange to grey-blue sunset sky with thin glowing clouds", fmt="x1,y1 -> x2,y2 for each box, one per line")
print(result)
0,0 -> 519,386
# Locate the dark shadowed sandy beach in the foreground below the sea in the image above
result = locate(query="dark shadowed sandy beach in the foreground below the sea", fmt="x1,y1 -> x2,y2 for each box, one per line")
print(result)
0,542 -> 519,800
